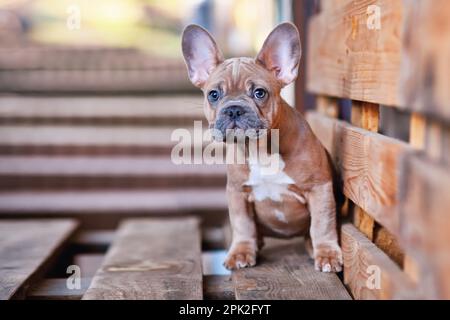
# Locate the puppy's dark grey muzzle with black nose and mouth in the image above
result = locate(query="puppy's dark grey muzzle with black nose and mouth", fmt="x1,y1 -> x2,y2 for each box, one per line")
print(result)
213,107 -> 268,141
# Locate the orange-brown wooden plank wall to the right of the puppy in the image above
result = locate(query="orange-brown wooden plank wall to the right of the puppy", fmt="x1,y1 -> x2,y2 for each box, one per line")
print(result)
298,0 -> 450,299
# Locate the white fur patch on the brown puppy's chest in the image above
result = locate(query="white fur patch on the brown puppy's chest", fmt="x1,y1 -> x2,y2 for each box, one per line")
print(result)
244,155 -> 304,203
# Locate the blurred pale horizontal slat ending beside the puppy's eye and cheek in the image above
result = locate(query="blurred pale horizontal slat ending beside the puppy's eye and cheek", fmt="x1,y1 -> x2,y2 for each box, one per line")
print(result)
0,95 -> 204,125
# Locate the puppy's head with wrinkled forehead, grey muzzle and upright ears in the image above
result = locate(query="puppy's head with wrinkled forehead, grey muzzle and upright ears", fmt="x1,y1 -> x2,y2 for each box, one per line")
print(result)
182,23 -> 301,137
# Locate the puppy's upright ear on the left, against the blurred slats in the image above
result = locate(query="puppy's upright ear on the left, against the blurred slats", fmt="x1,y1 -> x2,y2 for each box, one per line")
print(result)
181,24 -> 223,88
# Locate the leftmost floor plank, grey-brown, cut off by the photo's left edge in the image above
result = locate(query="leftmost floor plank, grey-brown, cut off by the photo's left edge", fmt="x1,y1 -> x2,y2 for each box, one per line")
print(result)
0,219 -> 77,300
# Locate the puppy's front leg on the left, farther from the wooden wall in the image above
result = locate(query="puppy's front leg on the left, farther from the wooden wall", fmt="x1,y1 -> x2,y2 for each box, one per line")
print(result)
224,189 -> 258,270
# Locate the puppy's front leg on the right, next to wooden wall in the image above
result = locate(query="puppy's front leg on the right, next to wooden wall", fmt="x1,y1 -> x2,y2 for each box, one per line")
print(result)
307,182 -> 342,272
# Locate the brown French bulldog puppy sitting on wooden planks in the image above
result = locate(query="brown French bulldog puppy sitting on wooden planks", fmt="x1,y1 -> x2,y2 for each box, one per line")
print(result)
182,23 -> 342,272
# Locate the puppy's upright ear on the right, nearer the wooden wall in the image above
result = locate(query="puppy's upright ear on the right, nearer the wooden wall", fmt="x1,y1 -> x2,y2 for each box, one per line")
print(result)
256,22 -> 302,86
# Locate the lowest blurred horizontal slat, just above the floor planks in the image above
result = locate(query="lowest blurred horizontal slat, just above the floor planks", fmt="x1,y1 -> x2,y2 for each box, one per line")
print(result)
0,188 -> 228,229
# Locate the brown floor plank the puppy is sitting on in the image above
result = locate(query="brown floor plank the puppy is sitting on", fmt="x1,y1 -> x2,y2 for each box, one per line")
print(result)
232,239 -> 350,300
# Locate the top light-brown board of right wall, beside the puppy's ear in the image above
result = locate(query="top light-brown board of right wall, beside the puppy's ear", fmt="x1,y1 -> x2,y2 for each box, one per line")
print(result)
307,0 -> 403,106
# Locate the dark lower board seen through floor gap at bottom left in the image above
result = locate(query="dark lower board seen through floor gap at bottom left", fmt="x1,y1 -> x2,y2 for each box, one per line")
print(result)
27,278 -> 92,300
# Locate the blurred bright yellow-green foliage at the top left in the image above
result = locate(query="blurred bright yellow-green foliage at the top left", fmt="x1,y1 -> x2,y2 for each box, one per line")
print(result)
19,0 -> 198,57
